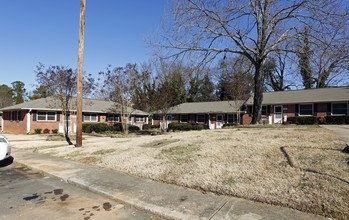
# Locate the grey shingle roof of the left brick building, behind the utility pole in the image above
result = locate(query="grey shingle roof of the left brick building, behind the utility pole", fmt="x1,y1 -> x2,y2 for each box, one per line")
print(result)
0,96 -> 149,115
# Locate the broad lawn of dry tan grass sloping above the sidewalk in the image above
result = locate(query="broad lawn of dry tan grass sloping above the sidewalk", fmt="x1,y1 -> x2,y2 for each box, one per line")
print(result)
7,126 -> 349,219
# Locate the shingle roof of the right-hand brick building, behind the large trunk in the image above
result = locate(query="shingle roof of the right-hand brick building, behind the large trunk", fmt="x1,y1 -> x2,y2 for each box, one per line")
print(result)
246,86 -> 349,105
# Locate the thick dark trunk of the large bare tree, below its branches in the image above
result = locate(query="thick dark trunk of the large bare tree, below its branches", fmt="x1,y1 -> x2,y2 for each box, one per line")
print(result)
252,62 -> 264,124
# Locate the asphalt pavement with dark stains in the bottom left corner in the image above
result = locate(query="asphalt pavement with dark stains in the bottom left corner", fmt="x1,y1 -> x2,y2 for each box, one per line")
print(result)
0,160 -> 158,220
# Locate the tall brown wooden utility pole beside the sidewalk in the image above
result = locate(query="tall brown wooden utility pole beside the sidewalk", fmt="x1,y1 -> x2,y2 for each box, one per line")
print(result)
76,0 -> 86,147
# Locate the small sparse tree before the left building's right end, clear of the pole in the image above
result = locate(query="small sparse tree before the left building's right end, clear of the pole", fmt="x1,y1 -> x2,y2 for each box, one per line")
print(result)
99,63 -> 143,134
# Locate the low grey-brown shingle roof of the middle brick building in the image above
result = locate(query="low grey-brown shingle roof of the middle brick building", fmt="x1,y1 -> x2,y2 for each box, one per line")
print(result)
168,100 -> 243,114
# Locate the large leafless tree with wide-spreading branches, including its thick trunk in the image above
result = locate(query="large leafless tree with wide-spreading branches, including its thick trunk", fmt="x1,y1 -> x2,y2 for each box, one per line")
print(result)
149,0 -> 348,124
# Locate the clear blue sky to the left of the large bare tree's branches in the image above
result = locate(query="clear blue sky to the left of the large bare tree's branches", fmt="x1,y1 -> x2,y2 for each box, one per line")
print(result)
0,0 -> 167,91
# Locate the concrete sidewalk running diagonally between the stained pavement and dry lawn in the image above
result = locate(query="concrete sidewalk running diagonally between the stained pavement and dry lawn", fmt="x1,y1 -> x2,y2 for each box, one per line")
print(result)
12,148 -> 326,220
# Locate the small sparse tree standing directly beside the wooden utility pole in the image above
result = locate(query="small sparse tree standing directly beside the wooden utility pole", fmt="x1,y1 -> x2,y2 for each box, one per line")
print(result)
36,63 -> 95,144
